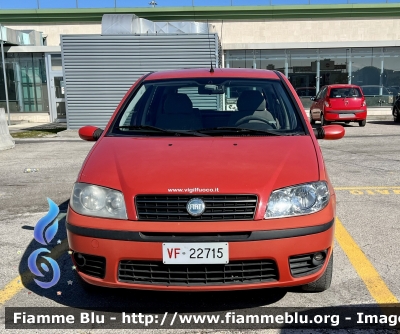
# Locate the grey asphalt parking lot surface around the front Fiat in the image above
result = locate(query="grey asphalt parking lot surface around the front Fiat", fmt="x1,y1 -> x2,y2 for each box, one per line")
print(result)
0,121 -> 400,333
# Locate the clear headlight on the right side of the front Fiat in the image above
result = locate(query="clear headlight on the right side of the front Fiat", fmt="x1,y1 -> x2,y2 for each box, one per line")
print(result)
264,181 -> 329,219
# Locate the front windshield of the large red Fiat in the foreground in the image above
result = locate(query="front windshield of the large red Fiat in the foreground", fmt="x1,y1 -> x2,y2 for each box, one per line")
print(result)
110,78 -> 305,136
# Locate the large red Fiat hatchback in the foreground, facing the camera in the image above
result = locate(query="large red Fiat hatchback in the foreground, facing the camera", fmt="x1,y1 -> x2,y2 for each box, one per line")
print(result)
66,69 -> 344,291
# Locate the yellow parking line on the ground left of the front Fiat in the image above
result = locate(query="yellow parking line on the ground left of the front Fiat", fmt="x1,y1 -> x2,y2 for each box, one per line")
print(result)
0,239 -> 68,305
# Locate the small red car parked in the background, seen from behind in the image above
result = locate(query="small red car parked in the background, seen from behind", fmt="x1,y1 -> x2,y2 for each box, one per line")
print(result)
310,84 -> 367,126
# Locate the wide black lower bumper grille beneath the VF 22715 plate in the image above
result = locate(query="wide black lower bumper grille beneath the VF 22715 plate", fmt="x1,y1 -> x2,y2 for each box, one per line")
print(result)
118,260 -> 279,286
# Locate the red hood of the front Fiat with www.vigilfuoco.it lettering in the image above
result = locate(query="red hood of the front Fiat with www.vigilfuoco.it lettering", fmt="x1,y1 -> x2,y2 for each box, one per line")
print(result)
78,136 -> 319,198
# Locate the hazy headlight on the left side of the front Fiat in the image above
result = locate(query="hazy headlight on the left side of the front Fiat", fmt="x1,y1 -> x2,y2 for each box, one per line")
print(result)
70,183 -> 127,219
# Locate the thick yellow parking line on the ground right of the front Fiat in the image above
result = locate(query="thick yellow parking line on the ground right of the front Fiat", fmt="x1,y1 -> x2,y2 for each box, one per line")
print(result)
335,217 -> 399,304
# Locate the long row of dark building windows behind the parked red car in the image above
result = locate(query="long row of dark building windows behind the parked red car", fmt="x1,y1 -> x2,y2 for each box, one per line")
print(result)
225,47 -> 400,108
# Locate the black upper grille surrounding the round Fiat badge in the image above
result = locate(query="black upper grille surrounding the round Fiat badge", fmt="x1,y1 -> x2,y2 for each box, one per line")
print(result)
136,195 -> 257,221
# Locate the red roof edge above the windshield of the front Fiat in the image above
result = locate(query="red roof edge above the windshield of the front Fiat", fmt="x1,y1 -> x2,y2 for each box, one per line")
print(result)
145,68 -> 279,81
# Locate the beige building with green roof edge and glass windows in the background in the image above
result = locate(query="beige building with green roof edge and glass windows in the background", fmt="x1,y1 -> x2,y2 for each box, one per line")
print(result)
0,3 -> 400,121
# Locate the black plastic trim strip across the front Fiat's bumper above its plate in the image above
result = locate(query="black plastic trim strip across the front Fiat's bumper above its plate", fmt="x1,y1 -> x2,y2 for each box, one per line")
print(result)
65,219 -> 335,242
